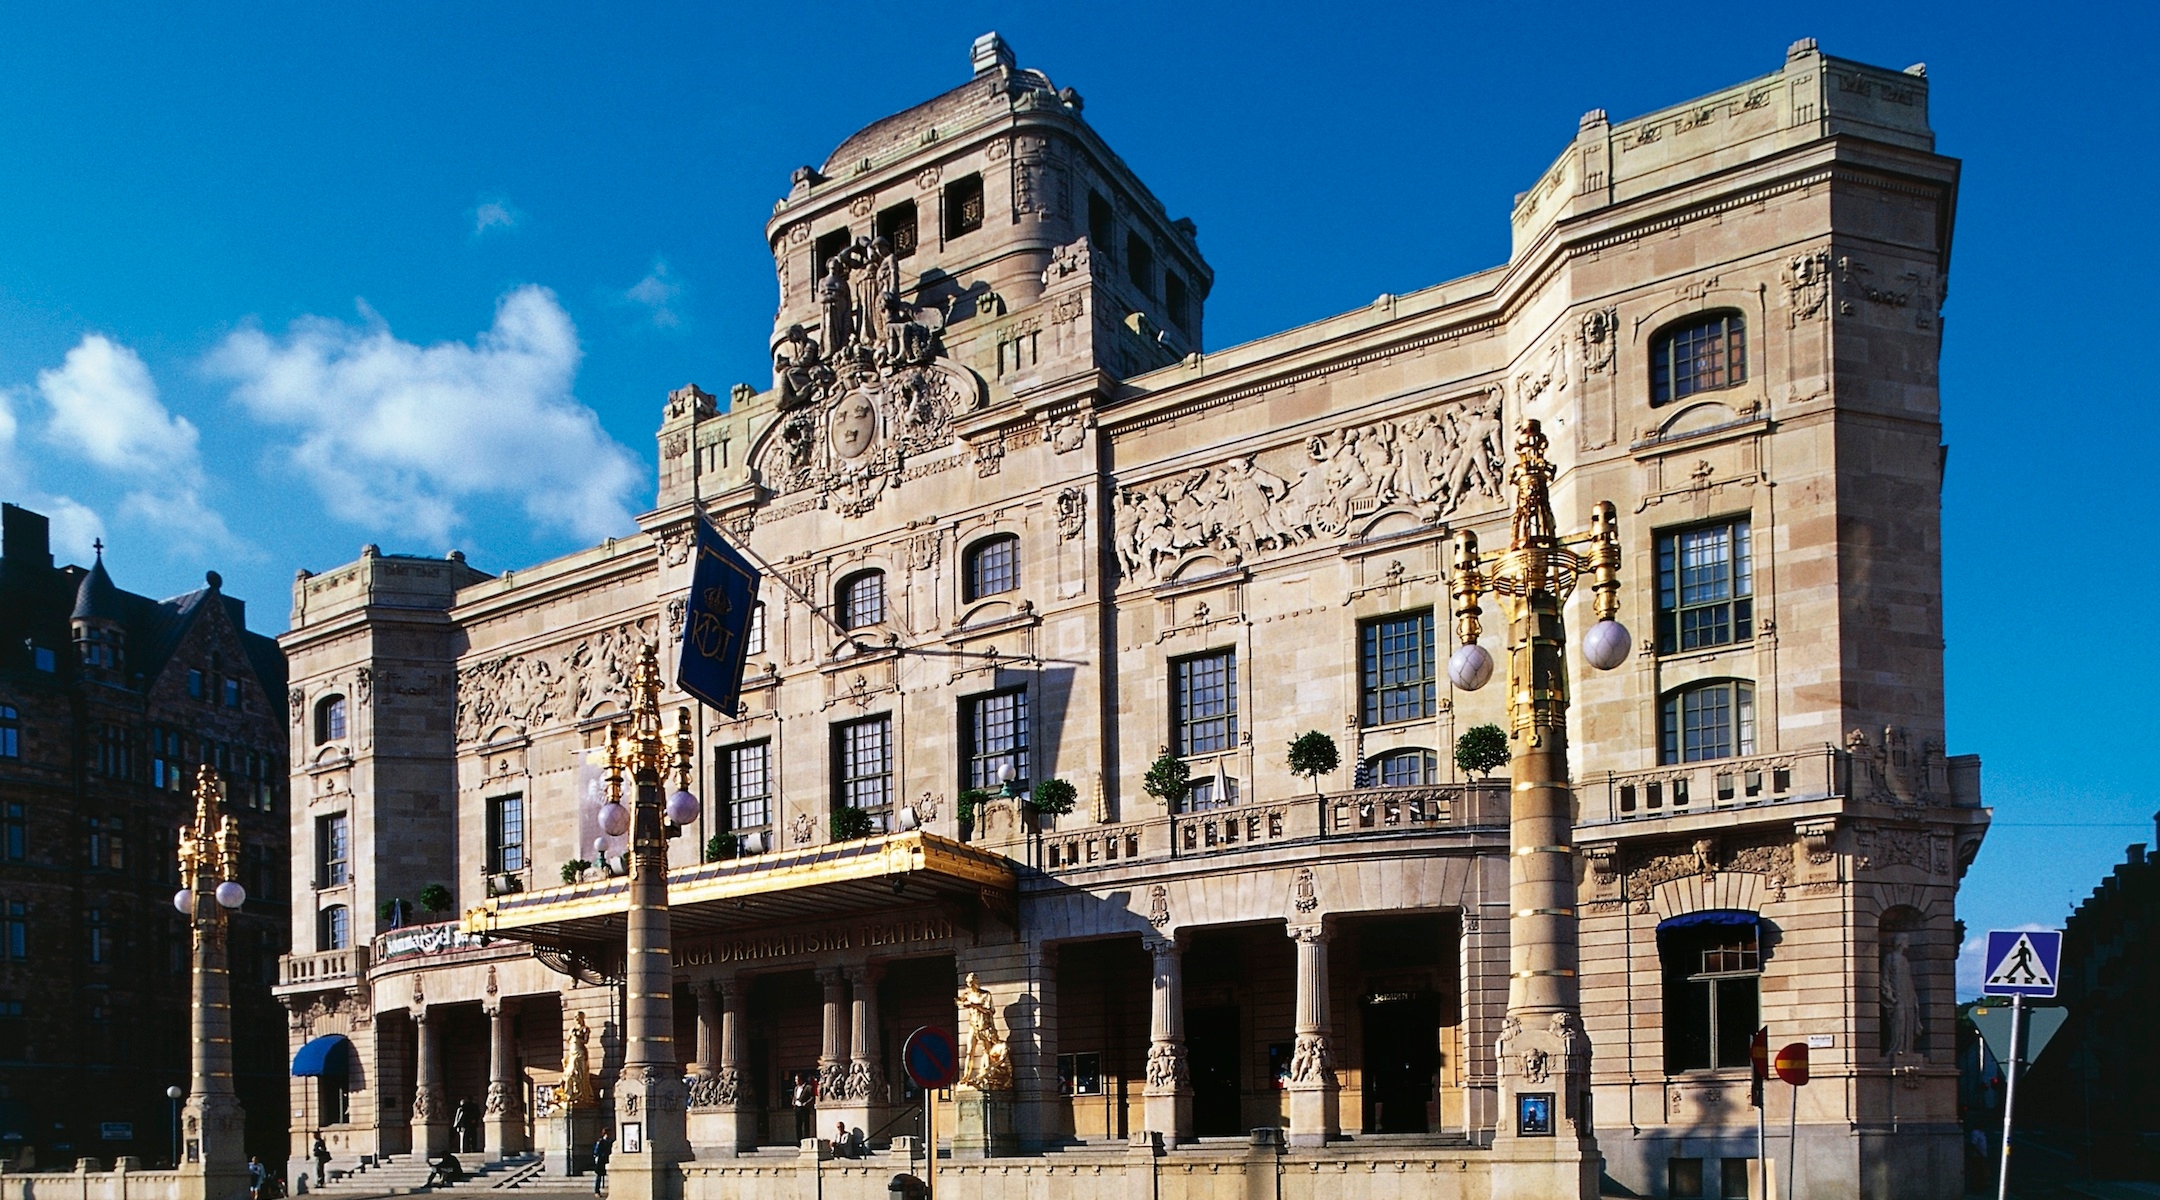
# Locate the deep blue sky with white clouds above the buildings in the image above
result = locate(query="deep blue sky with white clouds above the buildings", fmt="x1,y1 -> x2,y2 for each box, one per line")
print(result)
0,4 -> 2160,988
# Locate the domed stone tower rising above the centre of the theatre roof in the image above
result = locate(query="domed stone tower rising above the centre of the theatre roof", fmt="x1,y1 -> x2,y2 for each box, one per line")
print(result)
765,32 -> 1214,404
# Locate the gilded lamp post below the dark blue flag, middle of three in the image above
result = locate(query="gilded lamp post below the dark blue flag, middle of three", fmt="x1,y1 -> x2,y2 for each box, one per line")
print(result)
600,645 -> 700,1200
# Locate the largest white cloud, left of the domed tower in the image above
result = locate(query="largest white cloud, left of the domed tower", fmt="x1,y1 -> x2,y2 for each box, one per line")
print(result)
210,287 -> 644,542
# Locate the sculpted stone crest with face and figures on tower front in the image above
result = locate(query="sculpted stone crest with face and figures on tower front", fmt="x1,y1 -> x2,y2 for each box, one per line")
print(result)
752,237 -> 985,516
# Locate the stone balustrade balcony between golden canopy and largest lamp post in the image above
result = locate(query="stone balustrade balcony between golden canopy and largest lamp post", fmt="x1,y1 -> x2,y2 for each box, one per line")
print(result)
1043,779 -> 1508,872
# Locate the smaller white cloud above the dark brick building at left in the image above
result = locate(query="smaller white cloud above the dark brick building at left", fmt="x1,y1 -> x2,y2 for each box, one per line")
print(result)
31,332 -> 246,550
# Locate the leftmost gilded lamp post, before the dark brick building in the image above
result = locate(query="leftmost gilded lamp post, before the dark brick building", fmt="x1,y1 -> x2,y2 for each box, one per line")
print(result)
173,766 -> 248,1200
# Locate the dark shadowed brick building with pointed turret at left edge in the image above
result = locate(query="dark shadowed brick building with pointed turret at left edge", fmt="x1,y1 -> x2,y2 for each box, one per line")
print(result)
0,505 -> 287,1168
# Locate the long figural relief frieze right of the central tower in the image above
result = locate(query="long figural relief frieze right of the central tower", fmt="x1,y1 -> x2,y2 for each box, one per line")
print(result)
1115,395 -> 1506,578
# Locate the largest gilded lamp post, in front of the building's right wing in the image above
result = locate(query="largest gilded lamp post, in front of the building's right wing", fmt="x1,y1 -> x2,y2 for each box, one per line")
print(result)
1447,421 -> 1629,1196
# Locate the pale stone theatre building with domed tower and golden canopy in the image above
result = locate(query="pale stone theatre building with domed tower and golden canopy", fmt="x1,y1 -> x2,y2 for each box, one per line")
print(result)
279,37 -> 1987,1198
